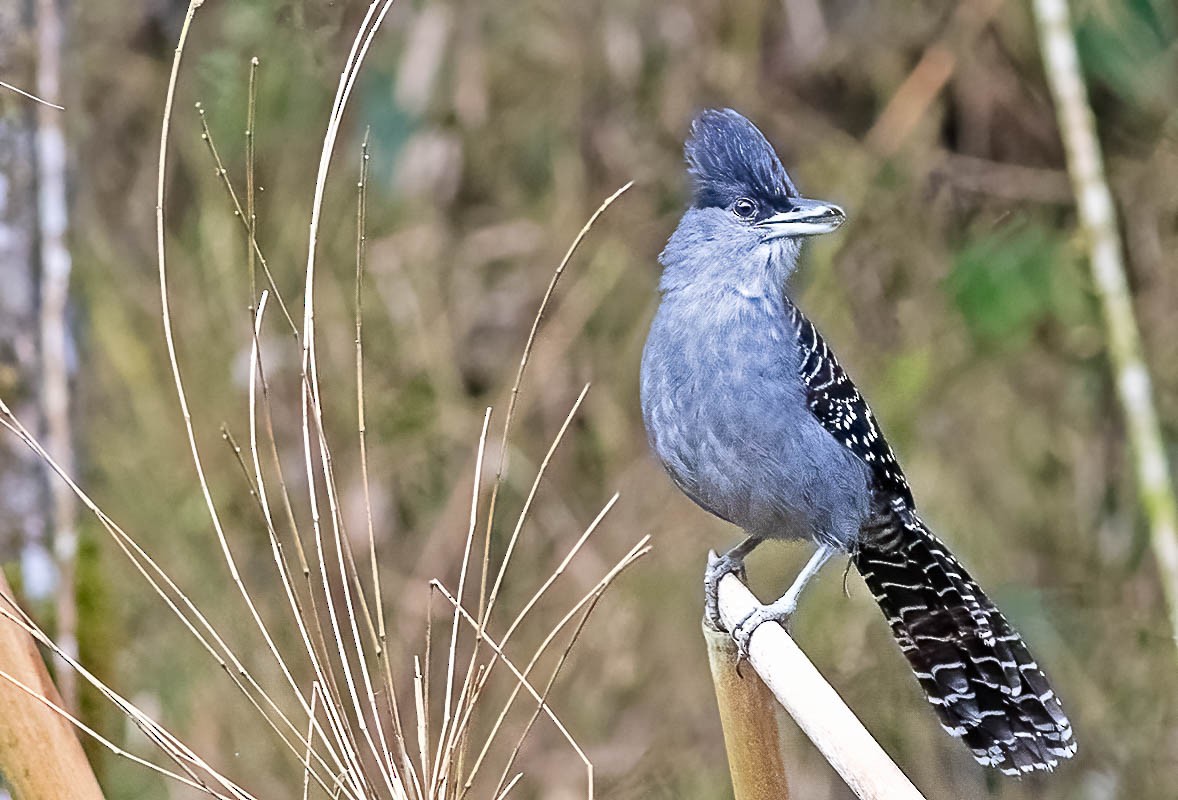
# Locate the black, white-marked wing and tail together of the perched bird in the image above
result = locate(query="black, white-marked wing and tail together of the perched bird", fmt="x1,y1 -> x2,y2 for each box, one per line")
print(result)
790,306 -> 1076,775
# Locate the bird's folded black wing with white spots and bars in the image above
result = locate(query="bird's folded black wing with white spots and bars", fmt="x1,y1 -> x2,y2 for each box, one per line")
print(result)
789,303 -> 915,509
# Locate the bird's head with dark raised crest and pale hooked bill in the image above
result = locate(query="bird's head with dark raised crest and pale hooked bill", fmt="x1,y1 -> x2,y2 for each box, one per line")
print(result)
684,108 -> 846,242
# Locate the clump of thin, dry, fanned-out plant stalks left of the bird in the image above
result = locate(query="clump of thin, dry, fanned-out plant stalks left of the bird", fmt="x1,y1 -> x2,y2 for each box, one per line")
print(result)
0,0 -> 649,800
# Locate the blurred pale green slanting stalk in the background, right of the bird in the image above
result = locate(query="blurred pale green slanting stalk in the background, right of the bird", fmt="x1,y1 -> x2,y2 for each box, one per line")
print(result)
1034,0 -> 1178,642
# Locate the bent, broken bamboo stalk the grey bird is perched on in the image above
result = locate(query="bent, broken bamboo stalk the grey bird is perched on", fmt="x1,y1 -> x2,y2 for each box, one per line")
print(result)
708,575 -> 925,800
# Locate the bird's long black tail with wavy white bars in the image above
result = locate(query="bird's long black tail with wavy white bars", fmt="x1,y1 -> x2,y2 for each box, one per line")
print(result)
853,516 -> 1076,775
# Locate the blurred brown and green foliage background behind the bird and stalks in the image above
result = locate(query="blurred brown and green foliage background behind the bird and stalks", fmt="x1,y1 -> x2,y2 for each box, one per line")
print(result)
2,0 -> 1178,800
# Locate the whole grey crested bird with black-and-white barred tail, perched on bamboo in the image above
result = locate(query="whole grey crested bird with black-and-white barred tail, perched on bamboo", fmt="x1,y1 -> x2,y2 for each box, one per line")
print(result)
640,108 -> 1077,775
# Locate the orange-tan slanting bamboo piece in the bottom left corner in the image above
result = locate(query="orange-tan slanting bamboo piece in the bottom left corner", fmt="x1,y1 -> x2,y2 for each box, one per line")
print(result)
0,573 -> 102,800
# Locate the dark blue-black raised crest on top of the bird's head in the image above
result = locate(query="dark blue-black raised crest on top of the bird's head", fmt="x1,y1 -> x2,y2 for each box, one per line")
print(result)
684,108 -> 798,206
